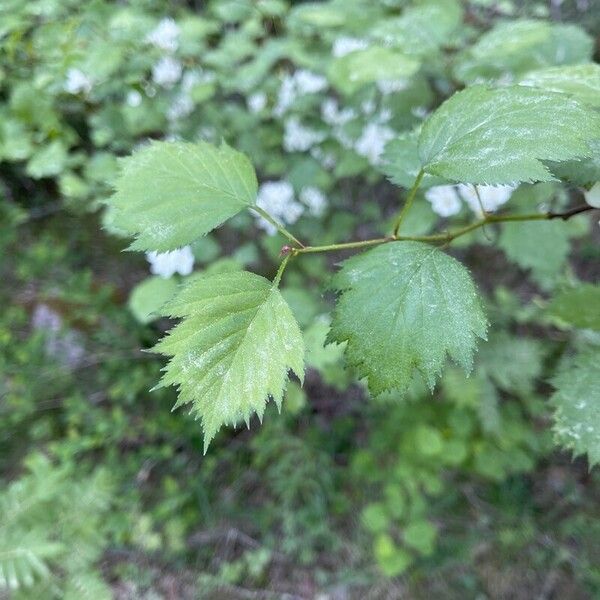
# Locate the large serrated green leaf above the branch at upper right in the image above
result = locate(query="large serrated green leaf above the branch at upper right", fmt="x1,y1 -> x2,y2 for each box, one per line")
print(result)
419,85 -> 600,184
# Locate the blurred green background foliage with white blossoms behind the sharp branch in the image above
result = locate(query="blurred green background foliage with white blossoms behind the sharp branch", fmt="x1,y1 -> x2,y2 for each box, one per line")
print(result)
0,0 -> 600,599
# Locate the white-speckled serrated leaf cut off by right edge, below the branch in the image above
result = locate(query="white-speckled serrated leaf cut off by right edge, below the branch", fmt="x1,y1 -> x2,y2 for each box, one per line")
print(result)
550,348 -> 600,466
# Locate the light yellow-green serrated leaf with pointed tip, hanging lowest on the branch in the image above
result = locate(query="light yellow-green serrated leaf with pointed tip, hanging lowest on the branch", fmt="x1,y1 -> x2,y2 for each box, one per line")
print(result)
154,271 -> 304,451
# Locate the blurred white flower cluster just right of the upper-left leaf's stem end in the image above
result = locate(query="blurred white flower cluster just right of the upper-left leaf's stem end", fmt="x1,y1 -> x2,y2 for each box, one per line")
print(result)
256,180 -> 327,235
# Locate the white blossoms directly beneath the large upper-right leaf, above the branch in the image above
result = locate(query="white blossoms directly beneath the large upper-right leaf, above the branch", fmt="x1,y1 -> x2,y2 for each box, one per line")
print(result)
425,184 -> 515,217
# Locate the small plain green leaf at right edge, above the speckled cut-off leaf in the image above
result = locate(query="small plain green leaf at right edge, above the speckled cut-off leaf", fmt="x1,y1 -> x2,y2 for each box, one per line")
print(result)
548,284 -> 600,330
